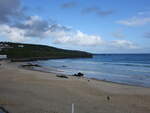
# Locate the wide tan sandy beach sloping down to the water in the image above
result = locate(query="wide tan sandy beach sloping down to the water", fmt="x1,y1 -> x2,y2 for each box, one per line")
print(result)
0,61 -> 150,113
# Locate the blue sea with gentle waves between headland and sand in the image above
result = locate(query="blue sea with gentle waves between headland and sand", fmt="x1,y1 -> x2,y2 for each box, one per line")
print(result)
33,54 -> 150,87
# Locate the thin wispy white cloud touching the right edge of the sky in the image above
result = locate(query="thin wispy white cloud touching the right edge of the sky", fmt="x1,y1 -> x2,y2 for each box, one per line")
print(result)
117,12 -> 150,26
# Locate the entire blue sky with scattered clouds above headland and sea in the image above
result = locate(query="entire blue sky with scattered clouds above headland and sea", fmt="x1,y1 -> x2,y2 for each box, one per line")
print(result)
0,0 -> 150,53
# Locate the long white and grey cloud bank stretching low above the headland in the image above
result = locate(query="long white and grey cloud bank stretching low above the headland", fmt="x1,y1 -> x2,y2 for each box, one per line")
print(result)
0,16 -> 137,49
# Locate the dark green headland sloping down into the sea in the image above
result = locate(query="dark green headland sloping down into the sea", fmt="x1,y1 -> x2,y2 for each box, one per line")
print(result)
0,42 -> 92,60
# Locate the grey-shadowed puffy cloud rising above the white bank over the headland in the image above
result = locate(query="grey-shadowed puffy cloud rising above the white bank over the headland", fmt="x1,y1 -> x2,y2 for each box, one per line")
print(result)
16,16 -> 71,38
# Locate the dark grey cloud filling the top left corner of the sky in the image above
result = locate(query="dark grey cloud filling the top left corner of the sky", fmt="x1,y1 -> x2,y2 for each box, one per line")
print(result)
0,0 -> 23,23
